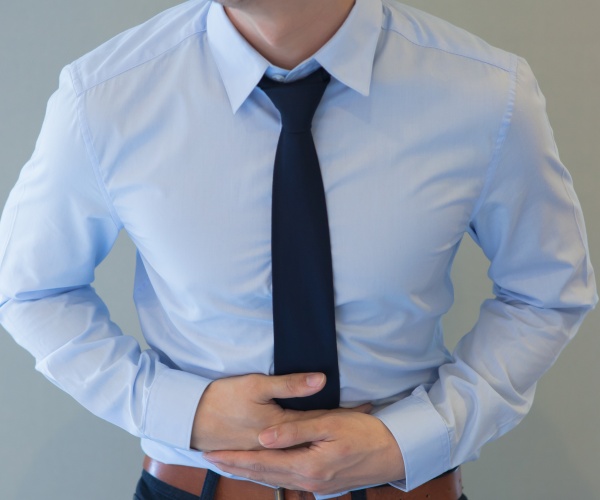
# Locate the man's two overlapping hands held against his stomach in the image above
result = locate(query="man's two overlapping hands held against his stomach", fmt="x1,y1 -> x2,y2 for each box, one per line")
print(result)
191,373 -> 404,495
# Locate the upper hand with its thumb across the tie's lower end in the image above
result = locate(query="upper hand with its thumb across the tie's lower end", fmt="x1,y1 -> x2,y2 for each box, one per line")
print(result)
191,373 -> 369,451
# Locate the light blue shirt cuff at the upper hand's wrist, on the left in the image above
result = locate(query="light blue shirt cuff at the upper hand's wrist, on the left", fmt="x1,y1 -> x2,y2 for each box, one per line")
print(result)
144,369 -> 212,450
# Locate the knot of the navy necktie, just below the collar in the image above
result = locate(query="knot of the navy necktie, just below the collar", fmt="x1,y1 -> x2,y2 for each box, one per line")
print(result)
258,68 -> 330,133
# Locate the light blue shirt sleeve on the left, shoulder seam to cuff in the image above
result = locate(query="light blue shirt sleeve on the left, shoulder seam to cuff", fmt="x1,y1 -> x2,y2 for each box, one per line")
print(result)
0,68 -> 209,449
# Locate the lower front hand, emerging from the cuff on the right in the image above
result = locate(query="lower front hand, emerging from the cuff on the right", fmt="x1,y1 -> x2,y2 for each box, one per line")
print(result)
204,412 -> 405,494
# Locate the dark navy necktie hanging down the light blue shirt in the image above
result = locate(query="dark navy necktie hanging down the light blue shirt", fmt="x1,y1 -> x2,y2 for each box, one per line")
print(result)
259,69 -> 340,410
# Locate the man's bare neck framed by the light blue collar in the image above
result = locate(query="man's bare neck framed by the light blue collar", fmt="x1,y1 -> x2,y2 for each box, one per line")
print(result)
220,0 -> 354,69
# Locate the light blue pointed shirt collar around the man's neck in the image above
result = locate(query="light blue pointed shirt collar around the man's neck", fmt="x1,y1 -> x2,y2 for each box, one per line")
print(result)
207,0 -> 383,113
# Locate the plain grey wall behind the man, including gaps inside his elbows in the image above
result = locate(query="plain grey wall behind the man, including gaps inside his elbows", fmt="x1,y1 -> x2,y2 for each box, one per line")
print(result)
0,0 -> 600,500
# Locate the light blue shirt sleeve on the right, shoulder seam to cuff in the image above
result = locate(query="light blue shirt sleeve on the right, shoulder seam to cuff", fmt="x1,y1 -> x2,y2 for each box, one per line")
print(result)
377,60 -> 598,490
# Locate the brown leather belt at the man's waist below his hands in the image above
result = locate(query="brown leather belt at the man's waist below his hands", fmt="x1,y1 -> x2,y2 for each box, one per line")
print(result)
144,456 -> 462,500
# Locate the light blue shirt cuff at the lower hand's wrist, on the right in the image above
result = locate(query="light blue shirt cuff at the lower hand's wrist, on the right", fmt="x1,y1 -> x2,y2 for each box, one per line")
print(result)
373,387 -> 451,491
